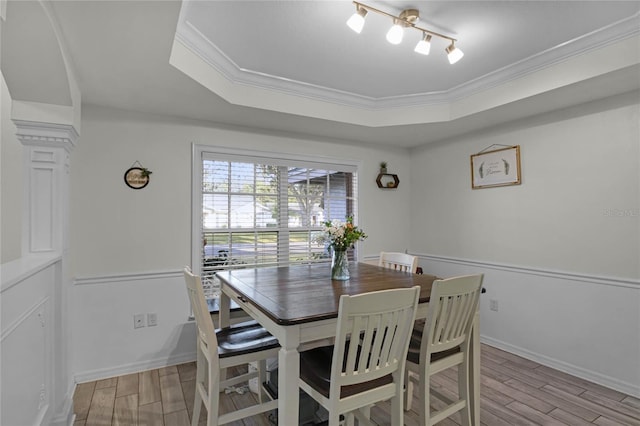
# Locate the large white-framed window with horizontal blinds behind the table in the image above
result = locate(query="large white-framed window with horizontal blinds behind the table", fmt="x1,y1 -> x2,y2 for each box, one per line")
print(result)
192,146 -> 357,277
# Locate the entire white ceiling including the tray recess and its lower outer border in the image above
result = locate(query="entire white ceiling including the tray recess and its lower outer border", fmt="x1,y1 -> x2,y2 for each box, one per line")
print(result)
2,0 -> 640,148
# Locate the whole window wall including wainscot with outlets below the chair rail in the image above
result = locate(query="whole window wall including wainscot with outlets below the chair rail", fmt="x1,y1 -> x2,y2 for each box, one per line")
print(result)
70,107 -> 411,380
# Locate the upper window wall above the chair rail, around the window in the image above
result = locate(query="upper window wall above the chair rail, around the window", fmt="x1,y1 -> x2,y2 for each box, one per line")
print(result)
71,107 -> 411,277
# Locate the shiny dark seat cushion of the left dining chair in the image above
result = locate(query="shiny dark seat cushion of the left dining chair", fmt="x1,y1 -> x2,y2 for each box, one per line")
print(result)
216,321 -> 279,358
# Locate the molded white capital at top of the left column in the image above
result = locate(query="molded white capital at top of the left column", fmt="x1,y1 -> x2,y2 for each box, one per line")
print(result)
13,119 -> 79,152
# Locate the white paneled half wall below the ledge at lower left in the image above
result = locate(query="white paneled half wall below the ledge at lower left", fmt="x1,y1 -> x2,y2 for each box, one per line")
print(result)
0,254 -> 67,425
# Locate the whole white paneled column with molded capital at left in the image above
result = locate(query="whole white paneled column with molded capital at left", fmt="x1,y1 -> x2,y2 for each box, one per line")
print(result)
13,119 -> 78,424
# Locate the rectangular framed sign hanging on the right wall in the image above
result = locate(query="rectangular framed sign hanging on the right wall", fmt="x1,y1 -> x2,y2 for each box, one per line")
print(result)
471,145 -> 520,189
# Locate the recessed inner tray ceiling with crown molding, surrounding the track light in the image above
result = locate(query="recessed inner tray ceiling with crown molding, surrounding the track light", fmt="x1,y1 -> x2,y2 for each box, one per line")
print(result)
174,0 -> 639,98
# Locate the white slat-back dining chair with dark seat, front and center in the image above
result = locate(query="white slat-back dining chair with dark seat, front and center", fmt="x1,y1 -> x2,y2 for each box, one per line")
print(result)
299,286 -> 420,426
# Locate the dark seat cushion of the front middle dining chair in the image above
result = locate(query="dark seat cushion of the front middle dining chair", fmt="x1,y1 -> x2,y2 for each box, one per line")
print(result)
300,346 -> 393,398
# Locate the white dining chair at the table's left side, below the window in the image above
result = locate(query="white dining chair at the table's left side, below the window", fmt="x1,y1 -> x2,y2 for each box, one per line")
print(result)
184,268 -> 280,426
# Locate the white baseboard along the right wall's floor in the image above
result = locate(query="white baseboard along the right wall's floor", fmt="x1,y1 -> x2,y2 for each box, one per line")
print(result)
480,335 -> 640,398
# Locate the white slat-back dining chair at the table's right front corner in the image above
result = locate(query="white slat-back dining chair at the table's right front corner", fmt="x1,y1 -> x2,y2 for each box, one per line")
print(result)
405,274 -> 483,426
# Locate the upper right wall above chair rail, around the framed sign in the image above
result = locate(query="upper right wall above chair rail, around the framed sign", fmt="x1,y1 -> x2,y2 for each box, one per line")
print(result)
411,93 -> 640,279
